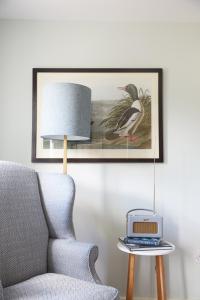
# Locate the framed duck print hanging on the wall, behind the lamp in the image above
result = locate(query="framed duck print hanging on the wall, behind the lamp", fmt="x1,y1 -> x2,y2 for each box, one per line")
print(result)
32,68 -> 163,162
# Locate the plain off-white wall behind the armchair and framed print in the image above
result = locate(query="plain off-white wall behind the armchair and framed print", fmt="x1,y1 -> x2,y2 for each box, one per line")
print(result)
0,21 -> 200,300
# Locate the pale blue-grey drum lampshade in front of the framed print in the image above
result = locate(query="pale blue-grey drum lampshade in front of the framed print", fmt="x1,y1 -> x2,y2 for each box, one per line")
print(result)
41,83 -> 91,141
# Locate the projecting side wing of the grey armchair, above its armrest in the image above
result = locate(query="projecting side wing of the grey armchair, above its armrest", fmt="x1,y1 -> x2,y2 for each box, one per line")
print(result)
38,173 -> 75,239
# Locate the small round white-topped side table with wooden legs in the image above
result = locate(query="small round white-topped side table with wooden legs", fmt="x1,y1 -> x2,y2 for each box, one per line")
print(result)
117,242 -> 175,300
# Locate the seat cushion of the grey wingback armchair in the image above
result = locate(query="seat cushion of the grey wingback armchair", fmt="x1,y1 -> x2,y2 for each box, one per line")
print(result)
3,273 -> 118,300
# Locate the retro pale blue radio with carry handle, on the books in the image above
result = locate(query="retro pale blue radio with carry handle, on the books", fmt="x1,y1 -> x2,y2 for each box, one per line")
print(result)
126,208 -> 163,238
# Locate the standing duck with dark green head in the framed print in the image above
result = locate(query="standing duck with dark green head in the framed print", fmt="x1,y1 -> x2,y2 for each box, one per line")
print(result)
101,84 -> 145,141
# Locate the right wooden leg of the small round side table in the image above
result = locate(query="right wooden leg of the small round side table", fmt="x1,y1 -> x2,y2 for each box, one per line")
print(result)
156,255 -> 166,300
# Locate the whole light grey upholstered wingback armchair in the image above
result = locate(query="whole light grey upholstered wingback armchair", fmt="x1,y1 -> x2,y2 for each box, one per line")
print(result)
0,162 -> 119,300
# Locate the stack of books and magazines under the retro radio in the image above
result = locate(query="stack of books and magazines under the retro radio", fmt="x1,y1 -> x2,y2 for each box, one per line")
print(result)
119,237 -> 173,251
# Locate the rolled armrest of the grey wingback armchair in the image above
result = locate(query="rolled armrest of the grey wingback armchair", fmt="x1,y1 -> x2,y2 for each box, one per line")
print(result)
48,239 -> 101,283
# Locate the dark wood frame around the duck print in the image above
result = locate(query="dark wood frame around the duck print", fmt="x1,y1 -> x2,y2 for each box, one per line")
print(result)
32,68 -> 163,163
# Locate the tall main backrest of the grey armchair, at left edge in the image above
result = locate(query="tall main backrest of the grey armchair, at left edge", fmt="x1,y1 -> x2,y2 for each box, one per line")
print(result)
0,162 -> 48,287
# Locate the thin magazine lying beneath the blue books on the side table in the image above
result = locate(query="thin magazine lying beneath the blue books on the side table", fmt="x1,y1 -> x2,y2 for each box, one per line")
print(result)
119,237 -> 172,251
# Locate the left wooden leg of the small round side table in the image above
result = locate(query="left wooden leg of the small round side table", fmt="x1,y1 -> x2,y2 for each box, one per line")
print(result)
126,254 -> 135,300
